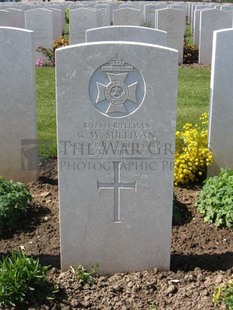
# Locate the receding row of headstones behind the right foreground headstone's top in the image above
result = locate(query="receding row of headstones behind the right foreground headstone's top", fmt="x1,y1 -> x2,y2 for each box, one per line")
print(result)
186,2 -> 233,65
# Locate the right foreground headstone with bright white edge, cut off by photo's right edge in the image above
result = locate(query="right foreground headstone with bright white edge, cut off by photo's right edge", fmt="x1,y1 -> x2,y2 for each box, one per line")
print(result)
208,29 -> 233,176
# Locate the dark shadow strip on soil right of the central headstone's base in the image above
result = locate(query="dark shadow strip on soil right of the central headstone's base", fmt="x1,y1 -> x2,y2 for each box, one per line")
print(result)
171,252 -> 233,272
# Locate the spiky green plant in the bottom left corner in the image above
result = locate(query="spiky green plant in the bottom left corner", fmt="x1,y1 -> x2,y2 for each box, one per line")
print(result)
0,251 -> 57,309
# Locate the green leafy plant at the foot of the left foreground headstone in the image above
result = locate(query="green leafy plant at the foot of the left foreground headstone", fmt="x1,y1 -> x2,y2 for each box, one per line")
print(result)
0,177 -> 32,235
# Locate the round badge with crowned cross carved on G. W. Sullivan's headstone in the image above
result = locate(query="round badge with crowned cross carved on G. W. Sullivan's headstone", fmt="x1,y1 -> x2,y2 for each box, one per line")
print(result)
89,55 -> 146,118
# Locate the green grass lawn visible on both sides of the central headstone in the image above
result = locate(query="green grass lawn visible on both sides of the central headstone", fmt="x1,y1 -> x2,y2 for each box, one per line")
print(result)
36,67 -> 210,156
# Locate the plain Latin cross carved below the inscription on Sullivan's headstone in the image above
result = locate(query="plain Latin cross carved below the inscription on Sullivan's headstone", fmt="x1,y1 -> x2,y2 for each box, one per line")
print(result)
97,161 -> 136,223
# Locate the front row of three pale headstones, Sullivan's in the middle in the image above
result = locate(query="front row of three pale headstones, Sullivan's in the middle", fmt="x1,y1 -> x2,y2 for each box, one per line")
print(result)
0,27 -> 233,273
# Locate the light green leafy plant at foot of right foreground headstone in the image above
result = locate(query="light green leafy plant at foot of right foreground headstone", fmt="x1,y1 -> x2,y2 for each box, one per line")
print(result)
196,168 -> 233,228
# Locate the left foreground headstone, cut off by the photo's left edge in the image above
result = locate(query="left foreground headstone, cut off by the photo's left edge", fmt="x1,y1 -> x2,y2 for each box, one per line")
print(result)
0,27 -> 38,182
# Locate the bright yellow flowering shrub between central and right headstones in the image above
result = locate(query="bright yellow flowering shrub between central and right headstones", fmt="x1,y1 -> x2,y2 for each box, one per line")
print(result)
174,113 -> 213,186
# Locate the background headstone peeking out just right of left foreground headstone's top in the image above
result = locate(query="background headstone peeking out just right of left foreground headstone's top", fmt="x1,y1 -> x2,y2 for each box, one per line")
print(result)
25,9 -> 53,62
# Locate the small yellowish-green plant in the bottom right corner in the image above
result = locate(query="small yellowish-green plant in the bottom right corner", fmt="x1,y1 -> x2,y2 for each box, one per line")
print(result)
213,281 -> 233,310
